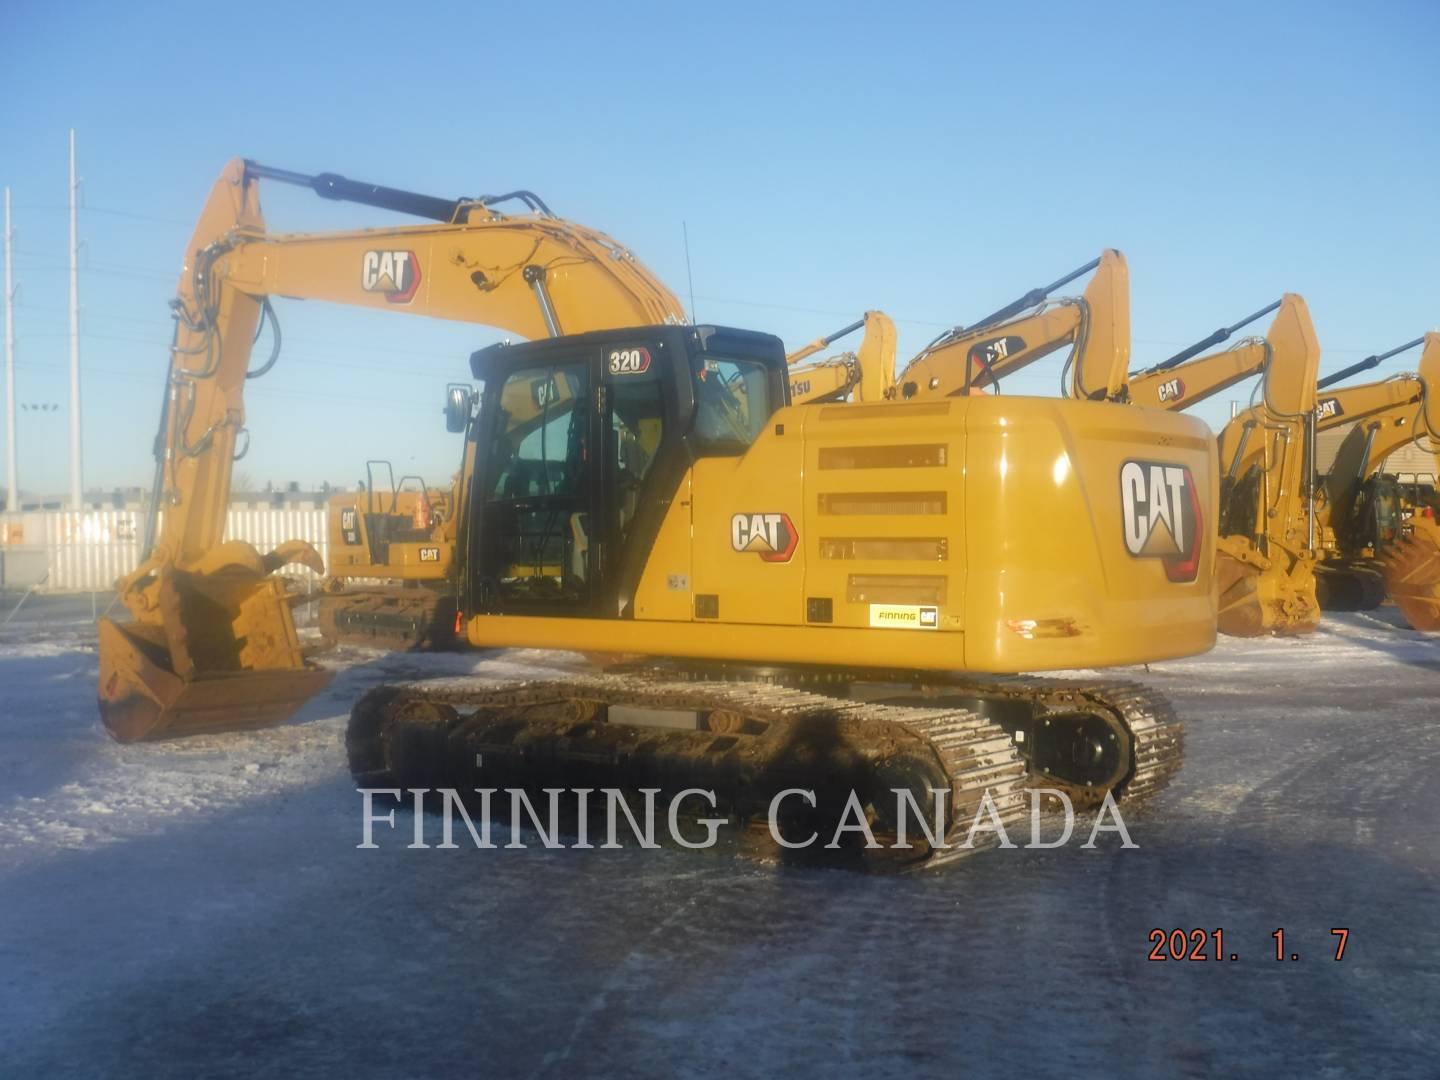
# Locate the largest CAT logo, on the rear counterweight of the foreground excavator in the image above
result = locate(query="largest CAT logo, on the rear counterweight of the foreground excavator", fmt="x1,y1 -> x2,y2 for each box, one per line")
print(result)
1120,461 -> 1204,582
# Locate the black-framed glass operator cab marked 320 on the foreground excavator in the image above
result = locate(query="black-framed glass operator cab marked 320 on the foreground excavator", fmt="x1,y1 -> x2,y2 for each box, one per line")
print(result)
446,325 -> 789,618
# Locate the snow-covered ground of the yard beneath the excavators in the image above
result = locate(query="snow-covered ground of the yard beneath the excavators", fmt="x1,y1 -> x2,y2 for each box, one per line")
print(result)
0,598 -> 1440,1077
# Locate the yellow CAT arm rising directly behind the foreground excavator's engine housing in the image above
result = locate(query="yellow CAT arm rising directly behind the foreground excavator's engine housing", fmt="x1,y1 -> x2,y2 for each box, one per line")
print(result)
897,249 -> 1130,400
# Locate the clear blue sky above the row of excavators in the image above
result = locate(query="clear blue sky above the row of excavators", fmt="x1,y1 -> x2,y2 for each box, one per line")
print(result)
0,0 -> 1440,492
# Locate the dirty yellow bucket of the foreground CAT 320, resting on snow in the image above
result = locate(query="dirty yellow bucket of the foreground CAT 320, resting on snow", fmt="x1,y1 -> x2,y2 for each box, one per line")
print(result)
99,566 -> 331,743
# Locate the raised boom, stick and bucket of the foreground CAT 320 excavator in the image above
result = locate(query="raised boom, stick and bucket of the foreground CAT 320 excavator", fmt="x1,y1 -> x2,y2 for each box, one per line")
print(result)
99,160 -> 684,740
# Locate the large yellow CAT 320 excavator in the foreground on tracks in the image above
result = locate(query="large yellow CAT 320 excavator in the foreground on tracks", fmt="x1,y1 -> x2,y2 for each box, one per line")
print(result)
101,161 -> 1218,863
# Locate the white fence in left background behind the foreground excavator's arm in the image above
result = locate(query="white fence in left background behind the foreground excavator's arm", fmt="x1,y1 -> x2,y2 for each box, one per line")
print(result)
0,507 -> 330,592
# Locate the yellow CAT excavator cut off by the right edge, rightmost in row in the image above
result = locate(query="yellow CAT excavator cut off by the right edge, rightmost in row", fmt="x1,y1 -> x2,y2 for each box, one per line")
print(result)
1316,333 -> 1440,631
